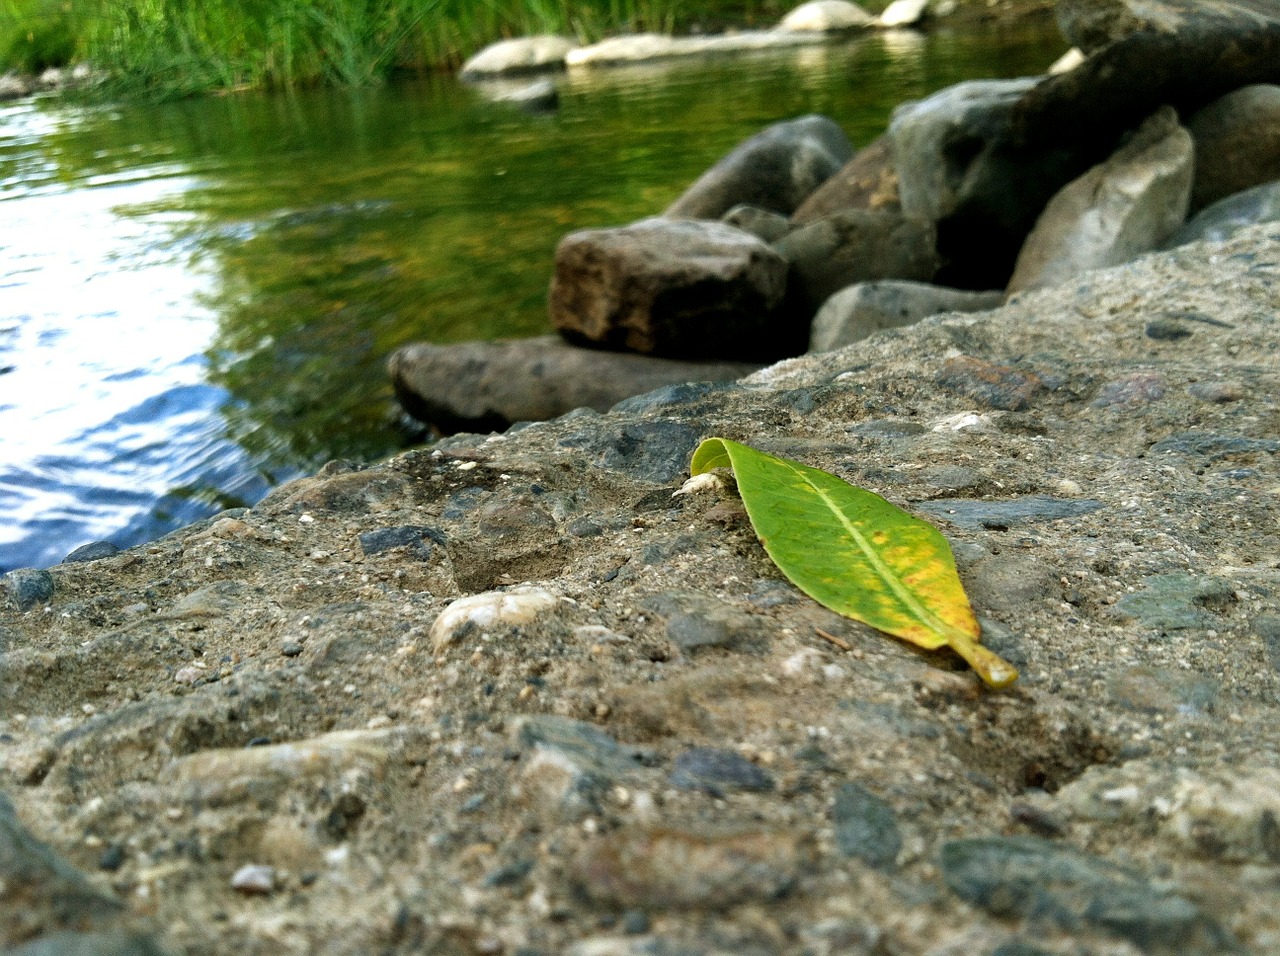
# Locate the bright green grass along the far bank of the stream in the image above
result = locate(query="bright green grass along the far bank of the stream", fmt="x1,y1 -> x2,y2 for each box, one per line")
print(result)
0,0 -> 794,97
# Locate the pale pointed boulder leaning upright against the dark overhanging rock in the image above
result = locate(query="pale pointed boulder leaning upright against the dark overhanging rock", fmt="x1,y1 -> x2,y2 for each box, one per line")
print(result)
1009,106 -> 1194,292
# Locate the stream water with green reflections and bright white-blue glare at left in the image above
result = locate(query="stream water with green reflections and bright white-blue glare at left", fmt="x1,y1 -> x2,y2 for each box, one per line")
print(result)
0,31 -> 1064,571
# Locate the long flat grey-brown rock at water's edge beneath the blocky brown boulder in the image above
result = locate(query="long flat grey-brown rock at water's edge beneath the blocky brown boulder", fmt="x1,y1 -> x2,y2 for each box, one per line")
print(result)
387,335 -> 759,433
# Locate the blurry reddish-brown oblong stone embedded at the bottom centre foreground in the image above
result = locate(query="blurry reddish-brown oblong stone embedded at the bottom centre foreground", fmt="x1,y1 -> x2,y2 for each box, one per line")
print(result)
572,829 -> 812,910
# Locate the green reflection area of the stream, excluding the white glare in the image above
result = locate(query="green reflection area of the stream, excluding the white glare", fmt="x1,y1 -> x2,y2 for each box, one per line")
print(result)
67,32 -> 1064,468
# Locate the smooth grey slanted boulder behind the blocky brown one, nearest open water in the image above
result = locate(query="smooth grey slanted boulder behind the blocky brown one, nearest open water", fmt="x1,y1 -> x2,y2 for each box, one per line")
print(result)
663,116 -> 854,219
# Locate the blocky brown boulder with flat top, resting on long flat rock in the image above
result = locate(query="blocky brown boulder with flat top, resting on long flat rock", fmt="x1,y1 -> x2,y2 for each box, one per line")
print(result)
550,219 -> 808,361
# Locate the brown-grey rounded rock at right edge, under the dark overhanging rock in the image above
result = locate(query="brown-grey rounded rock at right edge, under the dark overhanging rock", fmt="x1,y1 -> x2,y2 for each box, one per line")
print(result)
1187,83 -> 1280,212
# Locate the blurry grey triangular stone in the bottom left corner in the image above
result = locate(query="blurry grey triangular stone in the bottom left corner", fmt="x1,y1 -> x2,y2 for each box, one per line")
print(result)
0,793 -> 124,946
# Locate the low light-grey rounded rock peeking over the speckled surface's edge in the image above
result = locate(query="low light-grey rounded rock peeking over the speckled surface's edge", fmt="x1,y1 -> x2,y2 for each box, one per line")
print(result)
809,279 -> 1005,352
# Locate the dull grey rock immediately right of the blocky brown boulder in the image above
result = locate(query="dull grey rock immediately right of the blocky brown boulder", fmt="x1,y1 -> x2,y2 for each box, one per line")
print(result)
773,210 -> 941,315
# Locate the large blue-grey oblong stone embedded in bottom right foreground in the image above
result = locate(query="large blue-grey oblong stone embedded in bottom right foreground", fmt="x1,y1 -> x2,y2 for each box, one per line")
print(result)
941,837 -> 1240,956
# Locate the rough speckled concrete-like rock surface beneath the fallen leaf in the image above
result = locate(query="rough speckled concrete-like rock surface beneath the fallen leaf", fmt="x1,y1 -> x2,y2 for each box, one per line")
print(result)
0,224 -> 1280,956
